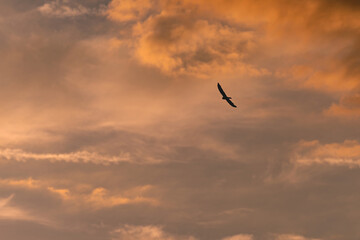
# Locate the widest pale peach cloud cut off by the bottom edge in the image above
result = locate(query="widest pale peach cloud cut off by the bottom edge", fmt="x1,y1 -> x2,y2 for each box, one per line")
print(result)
112,225 -> 196,240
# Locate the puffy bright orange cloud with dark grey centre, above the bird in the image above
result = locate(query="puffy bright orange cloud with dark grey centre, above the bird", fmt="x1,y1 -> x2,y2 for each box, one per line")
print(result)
134,13 -> 268,78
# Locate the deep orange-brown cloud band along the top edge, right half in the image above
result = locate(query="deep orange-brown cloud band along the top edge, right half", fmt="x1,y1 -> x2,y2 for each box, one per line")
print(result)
181,0 -> 360,35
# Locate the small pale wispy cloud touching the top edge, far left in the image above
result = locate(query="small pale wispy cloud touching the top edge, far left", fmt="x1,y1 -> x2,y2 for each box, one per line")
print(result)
38,0 -> 106,18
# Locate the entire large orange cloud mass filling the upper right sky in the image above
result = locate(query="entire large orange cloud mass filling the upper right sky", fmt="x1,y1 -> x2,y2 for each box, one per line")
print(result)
109,0 -> 360,98
